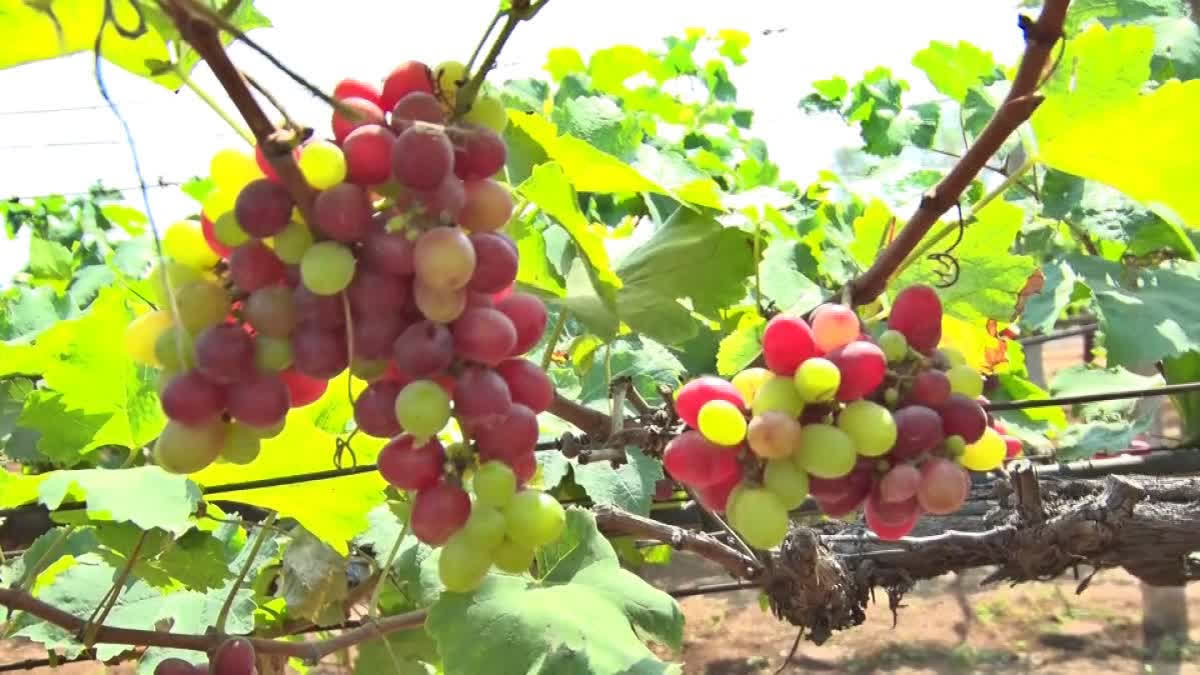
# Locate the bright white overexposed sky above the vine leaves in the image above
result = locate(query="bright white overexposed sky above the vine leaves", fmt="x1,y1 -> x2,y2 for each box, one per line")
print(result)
0,0 -> 1021,235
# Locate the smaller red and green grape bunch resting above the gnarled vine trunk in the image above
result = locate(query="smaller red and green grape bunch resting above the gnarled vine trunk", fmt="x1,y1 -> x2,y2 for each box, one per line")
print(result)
664,281 -> 1021,549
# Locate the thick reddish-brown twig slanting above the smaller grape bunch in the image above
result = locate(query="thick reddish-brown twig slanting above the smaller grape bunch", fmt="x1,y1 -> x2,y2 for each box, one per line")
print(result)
850,0 -> 1070,305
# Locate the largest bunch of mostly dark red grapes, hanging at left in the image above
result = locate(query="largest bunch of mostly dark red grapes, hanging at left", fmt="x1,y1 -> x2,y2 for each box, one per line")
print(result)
130,61 -> 565,590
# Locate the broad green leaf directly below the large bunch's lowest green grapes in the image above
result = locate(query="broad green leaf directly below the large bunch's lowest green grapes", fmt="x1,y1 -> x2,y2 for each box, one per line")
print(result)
426,509 -> 683,675
